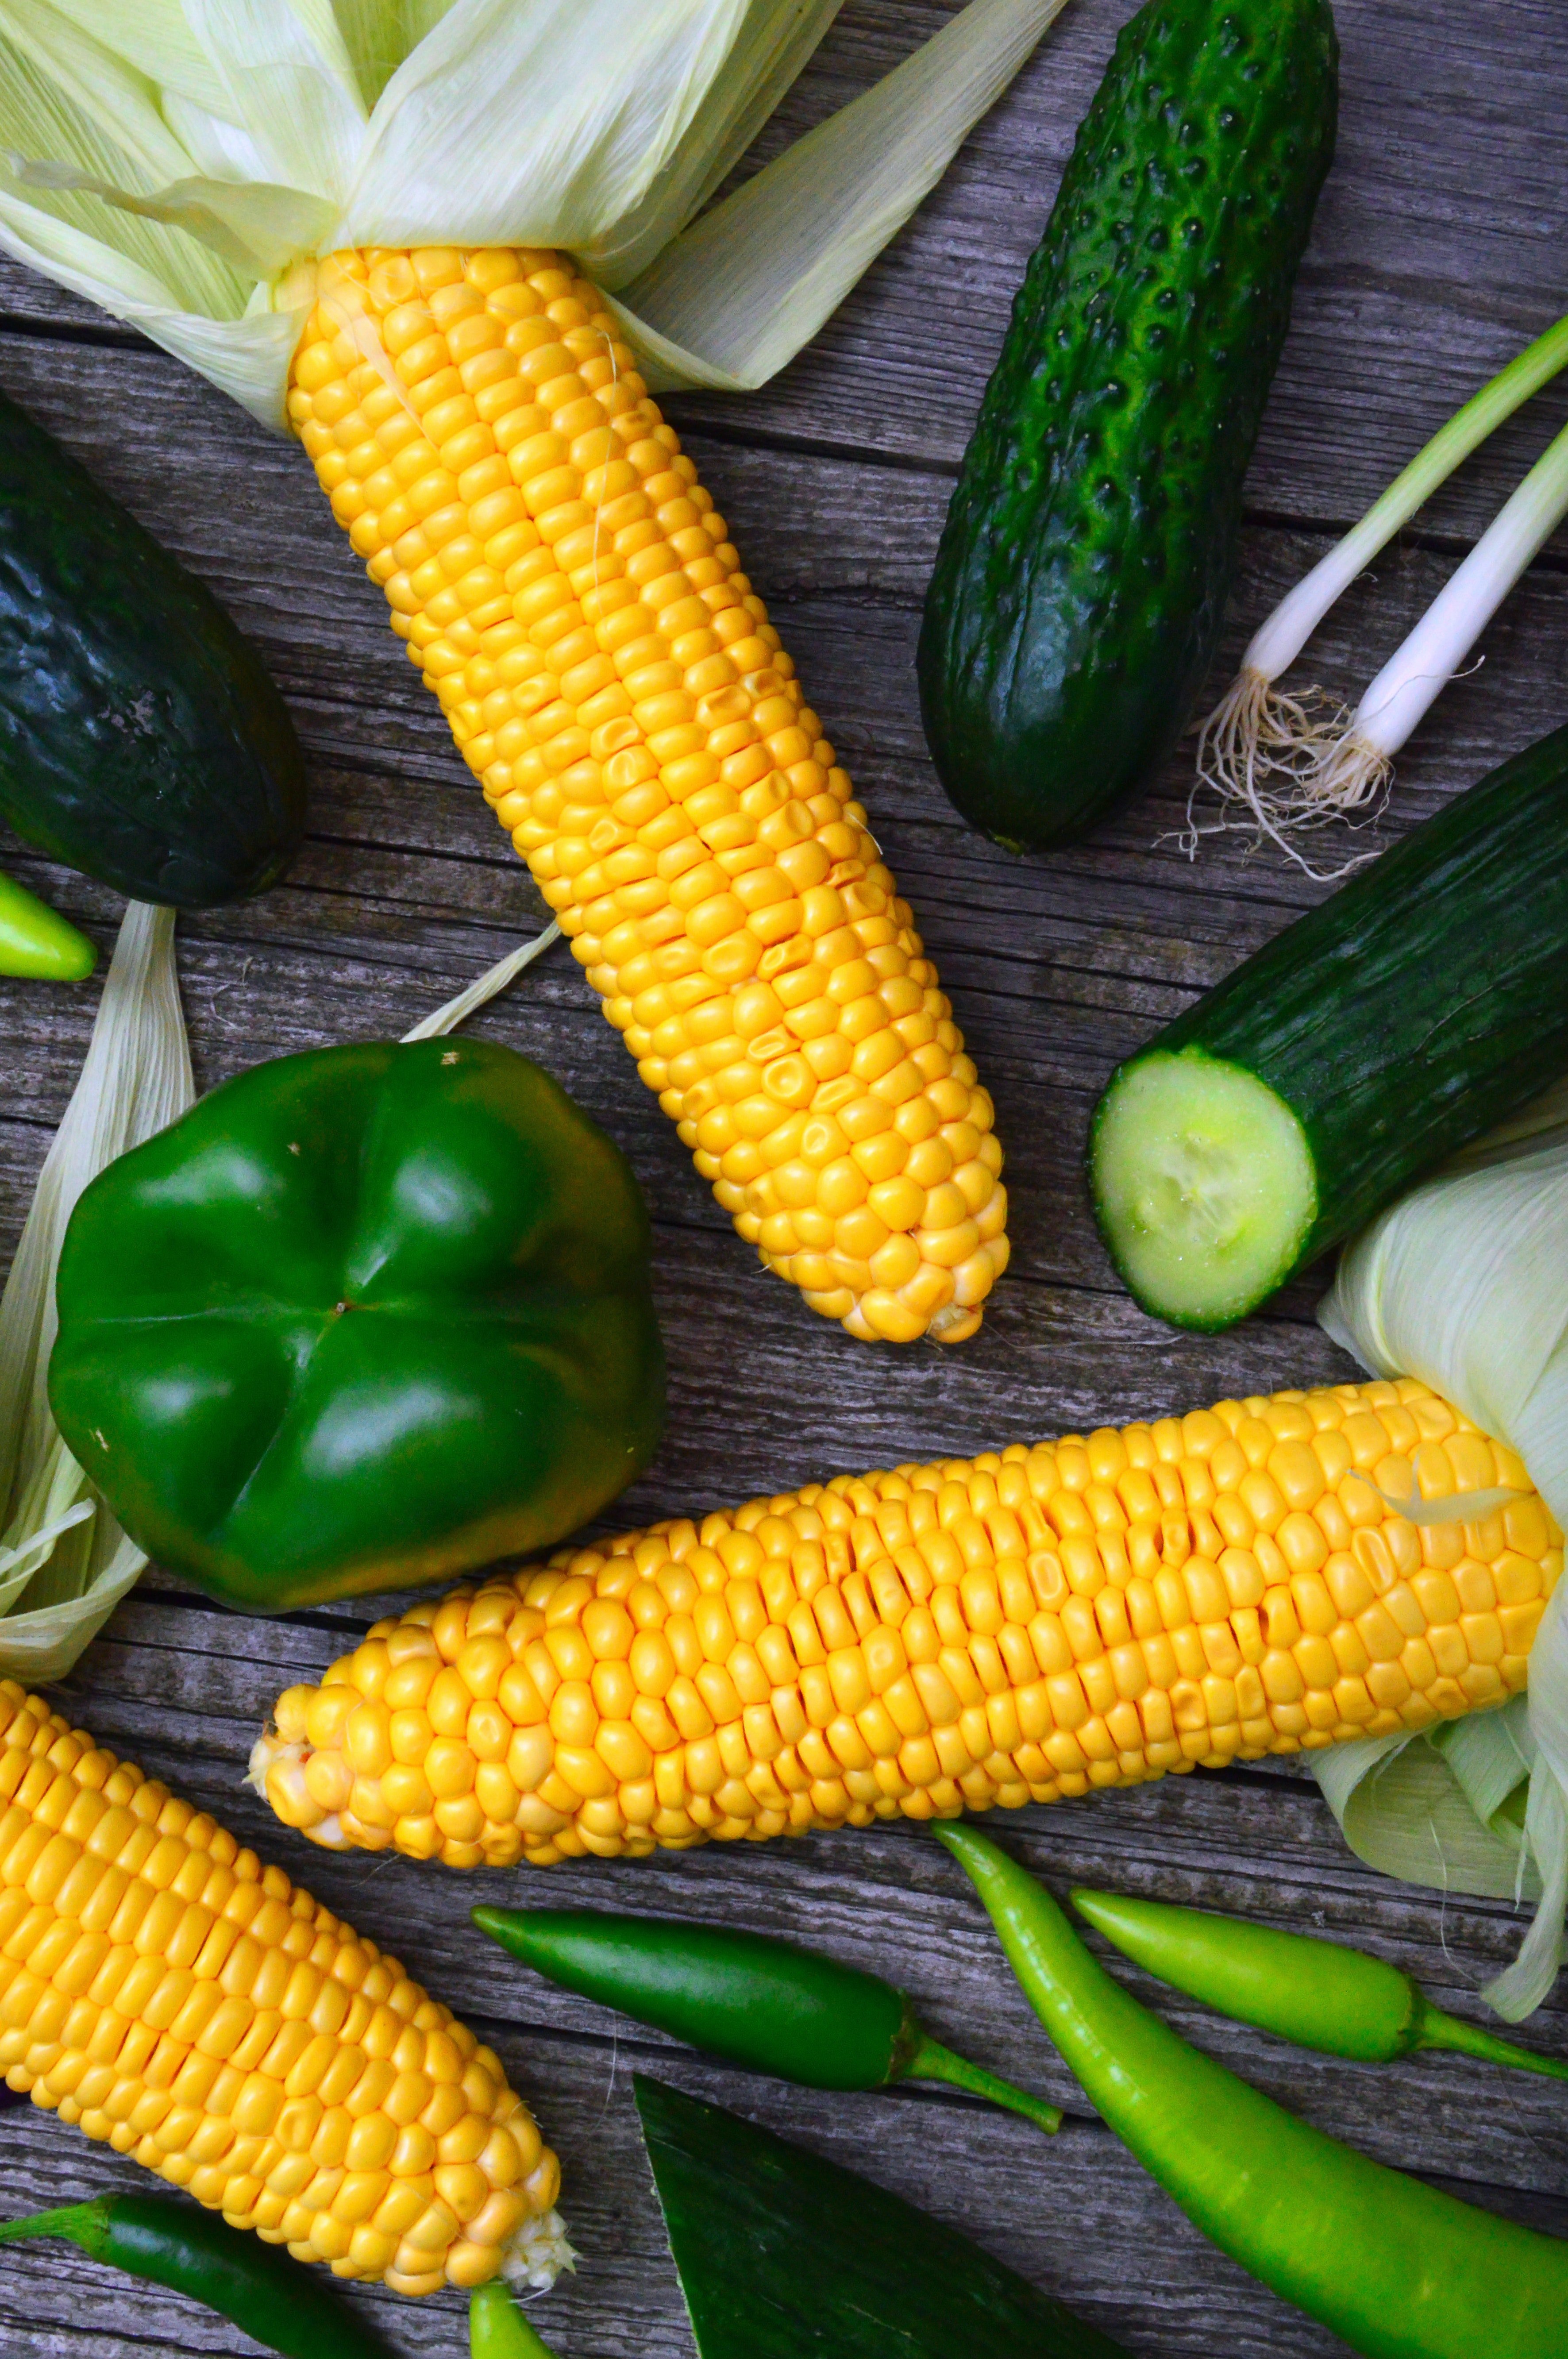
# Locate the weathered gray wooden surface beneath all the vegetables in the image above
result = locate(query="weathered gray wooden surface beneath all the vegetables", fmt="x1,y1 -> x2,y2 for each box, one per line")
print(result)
0,0 -> 1568,2359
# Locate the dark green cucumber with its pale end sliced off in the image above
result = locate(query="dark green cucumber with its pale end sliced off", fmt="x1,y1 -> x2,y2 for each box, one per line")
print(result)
1089,729 -> 1568,1328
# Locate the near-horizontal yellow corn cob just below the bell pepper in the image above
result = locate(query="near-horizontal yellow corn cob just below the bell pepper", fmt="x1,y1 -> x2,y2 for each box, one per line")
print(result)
252,1380 -> 1563,1868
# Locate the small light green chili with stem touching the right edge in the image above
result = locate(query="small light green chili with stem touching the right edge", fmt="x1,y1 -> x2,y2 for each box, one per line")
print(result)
1071,1892 -> 1568,2081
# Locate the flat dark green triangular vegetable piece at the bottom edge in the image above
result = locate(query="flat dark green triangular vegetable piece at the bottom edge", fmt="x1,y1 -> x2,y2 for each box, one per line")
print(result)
634,2074 -> 1127,2359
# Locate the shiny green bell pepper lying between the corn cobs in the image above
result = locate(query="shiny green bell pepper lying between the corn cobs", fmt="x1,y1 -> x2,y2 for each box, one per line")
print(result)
50,1041 -> 665,1611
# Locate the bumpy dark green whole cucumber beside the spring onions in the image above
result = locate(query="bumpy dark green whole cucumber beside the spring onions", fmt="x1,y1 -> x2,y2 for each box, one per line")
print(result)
920,0 -> 1339,852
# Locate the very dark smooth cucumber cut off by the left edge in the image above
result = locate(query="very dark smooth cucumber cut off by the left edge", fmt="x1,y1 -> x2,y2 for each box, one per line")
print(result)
0,396 -> 304,908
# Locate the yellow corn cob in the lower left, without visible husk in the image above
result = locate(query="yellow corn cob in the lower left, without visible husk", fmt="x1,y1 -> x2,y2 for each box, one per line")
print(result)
0,1680 -> 566,2293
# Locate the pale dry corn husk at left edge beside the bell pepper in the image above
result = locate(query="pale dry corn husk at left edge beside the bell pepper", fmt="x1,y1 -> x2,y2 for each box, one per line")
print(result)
0,901 -> 196,1687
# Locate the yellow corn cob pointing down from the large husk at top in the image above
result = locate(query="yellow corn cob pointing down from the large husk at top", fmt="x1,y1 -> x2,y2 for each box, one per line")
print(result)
288,248 -> 1007,1342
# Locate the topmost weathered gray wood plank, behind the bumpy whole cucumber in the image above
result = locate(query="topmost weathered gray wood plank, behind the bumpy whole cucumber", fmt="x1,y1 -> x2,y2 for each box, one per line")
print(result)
0,0 -> 1568,547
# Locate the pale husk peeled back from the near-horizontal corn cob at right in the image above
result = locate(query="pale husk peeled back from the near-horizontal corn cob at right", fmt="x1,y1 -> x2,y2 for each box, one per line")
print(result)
1314,1085 -> 1568,2022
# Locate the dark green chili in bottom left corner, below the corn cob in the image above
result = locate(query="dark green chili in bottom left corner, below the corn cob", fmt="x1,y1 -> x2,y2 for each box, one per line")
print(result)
0,2194 -> 391,2359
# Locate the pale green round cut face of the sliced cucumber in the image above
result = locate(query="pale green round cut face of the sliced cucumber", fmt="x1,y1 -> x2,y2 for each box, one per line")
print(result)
1089,1048 -> 1318,1328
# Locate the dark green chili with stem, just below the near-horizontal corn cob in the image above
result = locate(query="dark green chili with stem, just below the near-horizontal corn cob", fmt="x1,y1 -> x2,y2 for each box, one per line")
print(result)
474,1908 -> 1061,2130
